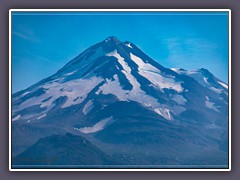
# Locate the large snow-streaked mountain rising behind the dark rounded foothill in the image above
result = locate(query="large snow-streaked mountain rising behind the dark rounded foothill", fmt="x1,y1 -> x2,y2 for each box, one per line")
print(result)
12,37 -> 228,166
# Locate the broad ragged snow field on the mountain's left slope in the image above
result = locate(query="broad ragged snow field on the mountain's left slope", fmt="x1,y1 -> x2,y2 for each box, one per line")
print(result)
14,77 -> 103,116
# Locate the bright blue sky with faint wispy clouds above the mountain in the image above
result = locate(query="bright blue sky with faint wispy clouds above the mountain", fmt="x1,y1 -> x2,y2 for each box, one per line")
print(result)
12,12 -> 228,92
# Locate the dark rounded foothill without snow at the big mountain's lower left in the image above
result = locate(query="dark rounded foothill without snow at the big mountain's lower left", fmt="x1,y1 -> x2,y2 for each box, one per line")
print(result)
13,133 -> 113,167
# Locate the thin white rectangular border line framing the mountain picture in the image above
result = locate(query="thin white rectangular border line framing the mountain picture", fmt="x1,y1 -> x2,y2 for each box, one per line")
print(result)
9,9 -> 231,171
